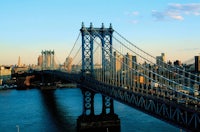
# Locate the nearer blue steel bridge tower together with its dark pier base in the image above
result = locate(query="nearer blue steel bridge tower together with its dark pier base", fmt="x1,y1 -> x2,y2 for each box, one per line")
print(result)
77,23 -> 120,132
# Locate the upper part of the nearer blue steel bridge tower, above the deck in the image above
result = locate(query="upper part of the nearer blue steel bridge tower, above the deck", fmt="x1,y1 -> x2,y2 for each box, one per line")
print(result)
80,23 -> 114,76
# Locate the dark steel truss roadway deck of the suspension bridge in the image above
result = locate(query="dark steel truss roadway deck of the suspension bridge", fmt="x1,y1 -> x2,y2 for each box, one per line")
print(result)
43,70 -> 200,131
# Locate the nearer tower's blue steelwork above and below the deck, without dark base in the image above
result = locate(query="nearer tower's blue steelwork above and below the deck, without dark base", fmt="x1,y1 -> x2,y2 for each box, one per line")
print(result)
79,23 -> 116,130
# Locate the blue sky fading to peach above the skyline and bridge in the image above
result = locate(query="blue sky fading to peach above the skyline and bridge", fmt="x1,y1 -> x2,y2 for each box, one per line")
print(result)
0,0 -> 200,65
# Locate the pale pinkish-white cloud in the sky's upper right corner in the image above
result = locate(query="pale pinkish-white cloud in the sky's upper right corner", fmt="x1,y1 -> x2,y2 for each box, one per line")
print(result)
152,3 -> 200,21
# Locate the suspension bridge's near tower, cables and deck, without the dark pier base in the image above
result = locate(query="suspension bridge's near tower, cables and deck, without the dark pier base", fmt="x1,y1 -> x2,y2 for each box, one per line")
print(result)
40,23 -> 200,131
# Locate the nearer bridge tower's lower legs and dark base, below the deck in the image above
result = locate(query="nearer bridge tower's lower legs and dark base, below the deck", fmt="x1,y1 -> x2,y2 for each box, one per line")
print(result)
77,88 -> 120,132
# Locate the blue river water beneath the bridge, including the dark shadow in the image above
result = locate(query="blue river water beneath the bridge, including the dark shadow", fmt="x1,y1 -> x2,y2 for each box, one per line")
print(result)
0,88 -> 180,132
